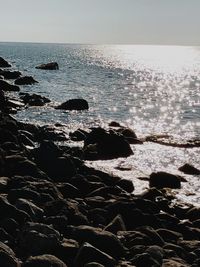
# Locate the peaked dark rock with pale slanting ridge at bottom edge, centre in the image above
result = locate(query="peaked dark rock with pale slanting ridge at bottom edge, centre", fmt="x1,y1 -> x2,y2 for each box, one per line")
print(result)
74,243 -> 116,267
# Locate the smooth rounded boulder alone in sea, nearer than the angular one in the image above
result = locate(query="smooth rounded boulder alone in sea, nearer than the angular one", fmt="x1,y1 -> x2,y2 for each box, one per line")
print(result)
56,98 -> 89,110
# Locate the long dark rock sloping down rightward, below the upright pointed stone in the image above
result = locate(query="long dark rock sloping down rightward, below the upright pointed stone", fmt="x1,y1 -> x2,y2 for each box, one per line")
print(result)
66,225 -> 125,259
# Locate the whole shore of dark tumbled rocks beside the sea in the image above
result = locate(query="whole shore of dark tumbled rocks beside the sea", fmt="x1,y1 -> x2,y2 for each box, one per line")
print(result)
0,58 -> 200,267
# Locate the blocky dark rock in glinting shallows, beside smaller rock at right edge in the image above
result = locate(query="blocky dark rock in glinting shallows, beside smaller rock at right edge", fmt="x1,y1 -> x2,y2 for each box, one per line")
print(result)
149,172 -> 181,189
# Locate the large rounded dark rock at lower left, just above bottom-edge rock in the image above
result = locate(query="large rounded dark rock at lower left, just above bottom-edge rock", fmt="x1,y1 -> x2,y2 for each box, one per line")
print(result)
19,223 -> 61,255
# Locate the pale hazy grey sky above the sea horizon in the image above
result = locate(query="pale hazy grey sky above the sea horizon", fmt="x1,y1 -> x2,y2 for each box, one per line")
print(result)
0,0 -> 200,45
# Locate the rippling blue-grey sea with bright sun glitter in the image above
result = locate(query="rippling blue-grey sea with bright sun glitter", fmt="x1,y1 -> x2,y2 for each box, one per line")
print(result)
0,42 -> 200,205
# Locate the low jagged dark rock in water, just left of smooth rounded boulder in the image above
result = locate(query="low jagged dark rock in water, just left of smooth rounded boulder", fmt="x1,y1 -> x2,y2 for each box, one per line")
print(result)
20,93 -> 51,106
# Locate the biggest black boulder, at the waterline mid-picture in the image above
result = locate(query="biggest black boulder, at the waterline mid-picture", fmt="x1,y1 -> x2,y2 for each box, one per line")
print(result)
84,128 -> 133,160
